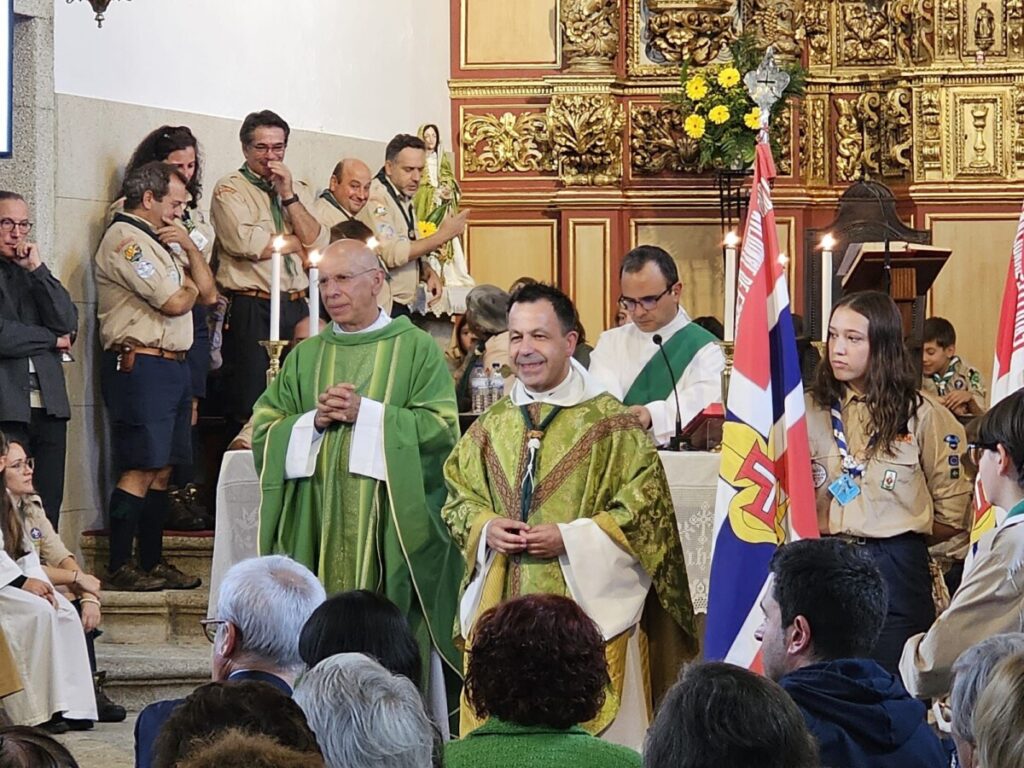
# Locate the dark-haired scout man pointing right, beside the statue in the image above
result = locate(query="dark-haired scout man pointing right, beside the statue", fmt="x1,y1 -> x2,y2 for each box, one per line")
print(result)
359,133 -> 469,316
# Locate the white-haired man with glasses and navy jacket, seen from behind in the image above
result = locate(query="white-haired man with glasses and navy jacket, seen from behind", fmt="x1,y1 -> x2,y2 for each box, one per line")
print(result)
135,555 -> 326,768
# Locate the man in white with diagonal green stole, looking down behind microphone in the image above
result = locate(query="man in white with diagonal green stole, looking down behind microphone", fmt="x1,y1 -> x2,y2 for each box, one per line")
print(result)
590,246 -> 725,445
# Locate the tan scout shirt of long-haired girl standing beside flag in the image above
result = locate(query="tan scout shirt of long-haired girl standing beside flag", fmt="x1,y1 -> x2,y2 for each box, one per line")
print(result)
806,392 -> 972,539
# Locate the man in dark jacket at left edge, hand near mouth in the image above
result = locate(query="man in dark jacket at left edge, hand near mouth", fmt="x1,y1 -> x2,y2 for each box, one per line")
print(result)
0,191 -> 78,529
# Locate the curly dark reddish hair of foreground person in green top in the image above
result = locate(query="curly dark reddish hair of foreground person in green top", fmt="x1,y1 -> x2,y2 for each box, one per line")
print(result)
466,595 -> 608,728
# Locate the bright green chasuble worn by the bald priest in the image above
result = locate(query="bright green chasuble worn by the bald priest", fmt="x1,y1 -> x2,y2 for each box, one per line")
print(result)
253,317 -> 463,689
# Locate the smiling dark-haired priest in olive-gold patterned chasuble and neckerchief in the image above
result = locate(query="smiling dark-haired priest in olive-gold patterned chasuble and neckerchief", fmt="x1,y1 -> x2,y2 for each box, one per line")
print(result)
441,285 -> 697,749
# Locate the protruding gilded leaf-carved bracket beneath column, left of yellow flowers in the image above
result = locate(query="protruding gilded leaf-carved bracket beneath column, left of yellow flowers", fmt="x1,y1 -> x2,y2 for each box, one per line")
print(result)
547,93 -> 626,186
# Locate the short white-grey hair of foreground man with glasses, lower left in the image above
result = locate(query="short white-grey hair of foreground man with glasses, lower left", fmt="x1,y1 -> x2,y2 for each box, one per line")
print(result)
216,555 -> 327,671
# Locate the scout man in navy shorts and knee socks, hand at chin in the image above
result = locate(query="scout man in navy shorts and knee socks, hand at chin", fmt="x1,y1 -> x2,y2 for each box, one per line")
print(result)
95,162 -> 217,591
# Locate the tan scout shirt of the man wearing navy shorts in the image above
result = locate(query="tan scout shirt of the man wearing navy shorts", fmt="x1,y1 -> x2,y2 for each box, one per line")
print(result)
95,214 -> 193,352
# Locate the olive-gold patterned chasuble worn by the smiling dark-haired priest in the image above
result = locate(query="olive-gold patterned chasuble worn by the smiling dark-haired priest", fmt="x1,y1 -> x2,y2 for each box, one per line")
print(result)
441,393 -> 697,735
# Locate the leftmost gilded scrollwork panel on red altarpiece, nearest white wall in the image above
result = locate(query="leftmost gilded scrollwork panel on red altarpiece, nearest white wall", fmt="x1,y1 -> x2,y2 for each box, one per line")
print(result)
462,112 -> 555,173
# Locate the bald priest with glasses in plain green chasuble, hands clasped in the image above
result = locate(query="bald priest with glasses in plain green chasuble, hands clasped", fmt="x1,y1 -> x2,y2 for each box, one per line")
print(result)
253,240 -> 463,719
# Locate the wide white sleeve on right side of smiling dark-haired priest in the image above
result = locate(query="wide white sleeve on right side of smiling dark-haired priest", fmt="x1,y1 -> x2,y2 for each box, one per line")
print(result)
558,518 -> 650,640
